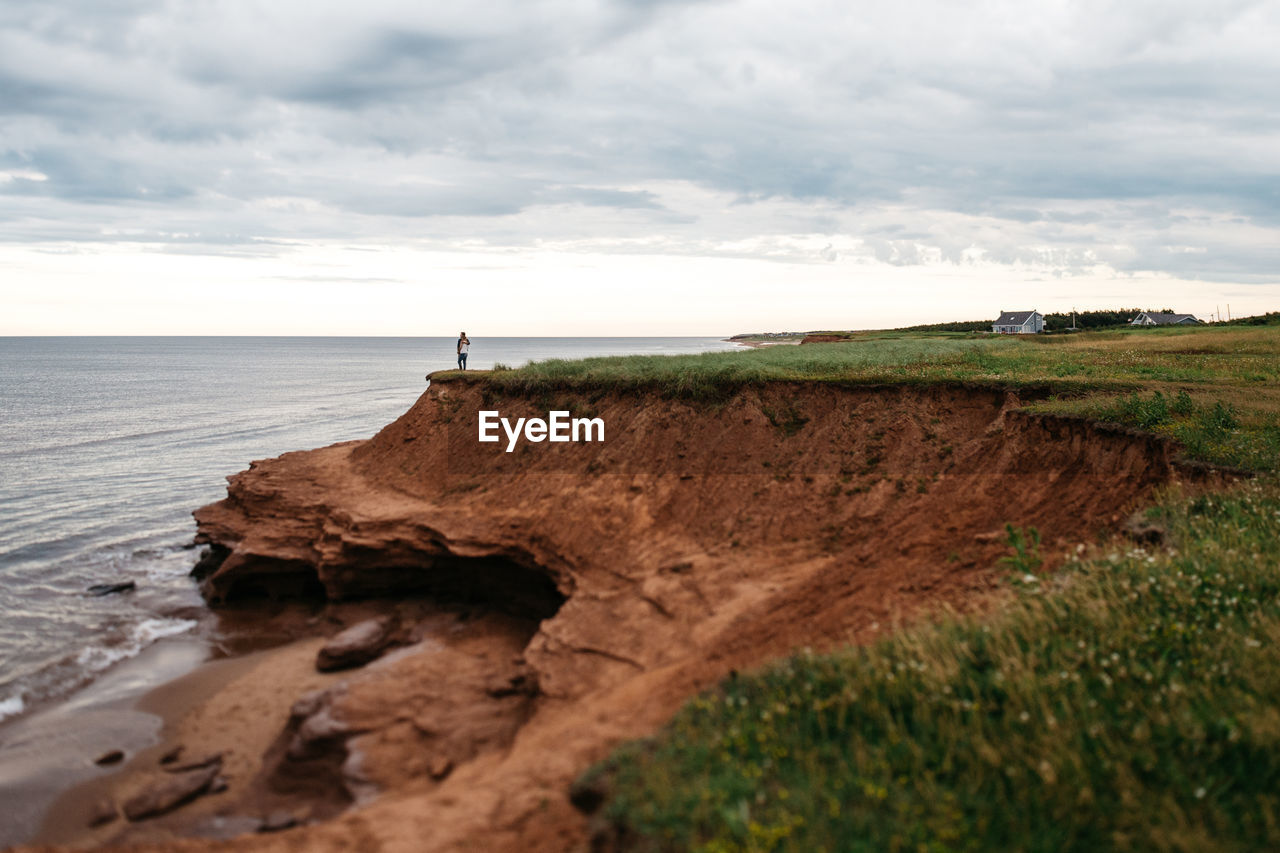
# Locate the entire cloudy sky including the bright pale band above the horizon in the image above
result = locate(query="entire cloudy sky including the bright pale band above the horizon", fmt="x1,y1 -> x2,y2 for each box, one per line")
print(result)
0,0 -> 1280,337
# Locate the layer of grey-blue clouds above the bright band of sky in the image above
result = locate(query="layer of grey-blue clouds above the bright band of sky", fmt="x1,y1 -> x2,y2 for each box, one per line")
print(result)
0,0 -> 1280,280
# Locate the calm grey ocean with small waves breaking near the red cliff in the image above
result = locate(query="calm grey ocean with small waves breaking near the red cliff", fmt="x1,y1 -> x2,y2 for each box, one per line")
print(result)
0,336 -> 736,720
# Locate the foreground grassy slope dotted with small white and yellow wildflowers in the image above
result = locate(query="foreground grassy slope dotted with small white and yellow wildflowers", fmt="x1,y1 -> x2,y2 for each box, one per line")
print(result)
581,479 -> 1280,853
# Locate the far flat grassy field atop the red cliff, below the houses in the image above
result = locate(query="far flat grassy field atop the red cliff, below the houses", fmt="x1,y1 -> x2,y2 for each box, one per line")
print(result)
471,325 -> 1280,470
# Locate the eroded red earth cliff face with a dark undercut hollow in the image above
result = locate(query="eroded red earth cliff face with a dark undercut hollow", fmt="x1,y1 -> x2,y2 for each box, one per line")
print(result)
172,382 -> 1185,850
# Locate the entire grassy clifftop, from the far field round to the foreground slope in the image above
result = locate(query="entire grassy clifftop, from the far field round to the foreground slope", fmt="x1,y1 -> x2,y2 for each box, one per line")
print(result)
486,327 -> 1280,853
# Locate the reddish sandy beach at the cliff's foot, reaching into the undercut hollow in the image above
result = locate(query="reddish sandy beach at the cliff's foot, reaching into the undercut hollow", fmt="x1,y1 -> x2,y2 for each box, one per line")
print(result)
6,598 -> 545,849
